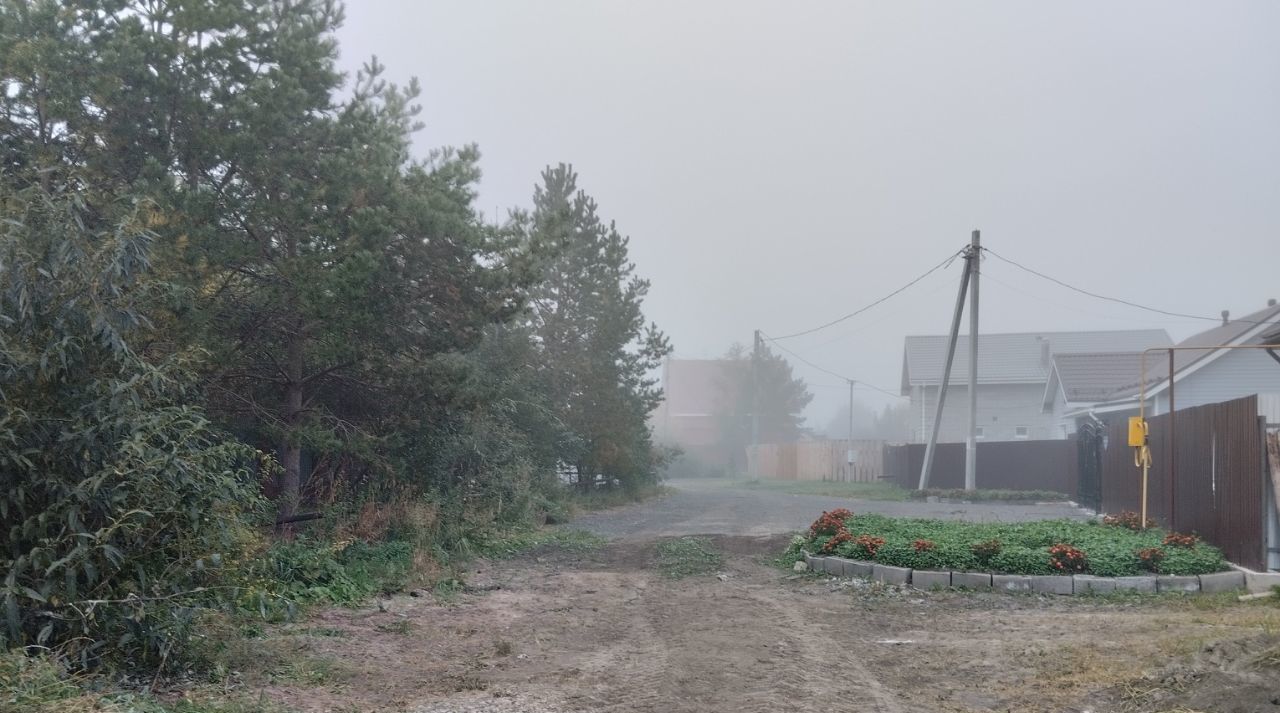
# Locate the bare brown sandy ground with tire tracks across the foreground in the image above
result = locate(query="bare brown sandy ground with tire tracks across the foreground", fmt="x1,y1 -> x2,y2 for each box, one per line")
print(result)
252,481 -> 1280,713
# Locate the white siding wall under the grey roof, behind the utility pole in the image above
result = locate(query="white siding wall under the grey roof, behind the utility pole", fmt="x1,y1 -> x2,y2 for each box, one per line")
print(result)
911,384 -> 1066,443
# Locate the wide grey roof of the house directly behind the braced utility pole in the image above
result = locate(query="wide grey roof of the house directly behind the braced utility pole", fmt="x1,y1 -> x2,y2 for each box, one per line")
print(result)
902,329 -> 1172,394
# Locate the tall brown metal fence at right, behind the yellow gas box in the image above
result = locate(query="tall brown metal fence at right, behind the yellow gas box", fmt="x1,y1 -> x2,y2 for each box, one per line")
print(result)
1102,397 -> 1266,568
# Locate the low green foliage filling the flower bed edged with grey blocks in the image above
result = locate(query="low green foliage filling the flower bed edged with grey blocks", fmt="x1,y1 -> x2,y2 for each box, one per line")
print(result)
804,513 -> 1228,577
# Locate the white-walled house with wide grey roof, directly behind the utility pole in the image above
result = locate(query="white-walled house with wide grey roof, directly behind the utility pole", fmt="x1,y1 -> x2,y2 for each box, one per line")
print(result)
901,329 -> 1172,443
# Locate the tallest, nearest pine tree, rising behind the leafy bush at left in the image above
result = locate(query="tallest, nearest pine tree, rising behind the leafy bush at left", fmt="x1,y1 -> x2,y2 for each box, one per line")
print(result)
0,0 -> 521,515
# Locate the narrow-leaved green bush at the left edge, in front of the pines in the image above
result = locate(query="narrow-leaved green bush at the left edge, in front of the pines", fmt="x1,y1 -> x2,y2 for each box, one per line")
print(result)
0,186 -> 270,667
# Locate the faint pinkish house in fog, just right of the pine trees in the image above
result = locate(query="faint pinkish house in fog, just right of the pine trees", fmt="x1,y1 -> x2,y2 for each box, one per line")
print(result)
652,358 -> 732,469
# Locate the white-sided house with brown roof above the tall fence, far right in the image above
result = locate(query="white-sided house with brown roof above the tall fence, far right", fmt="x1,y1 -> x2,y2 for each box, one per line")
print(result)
1042,300 -> 1280,433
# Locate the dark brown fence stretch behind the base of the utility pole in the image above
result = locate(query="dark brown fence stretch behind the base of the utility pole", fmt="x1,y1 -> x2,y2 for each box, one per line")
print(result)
884,440 -> 1079,497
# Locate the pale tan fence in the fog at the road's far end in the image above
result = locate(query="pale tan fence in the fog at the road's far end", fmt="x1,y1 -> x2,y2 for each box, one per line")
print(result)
746,440 -> 884,483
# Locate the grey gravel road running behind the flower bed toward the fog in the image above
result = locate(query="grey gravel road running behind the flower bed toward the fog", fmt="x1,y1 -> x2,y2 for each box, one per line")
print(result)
572,480 -> 1087,539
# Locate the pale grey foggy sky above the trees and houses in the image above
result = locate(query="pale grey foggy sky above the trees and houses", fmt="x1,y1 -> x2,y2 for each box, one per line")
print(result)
339,0 -> 1280,428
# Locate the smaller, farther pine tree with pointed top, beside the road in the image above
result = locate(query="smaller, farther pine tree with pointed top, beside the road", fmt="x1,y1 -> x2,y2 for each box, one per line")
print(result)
529,164 -> 671,488
